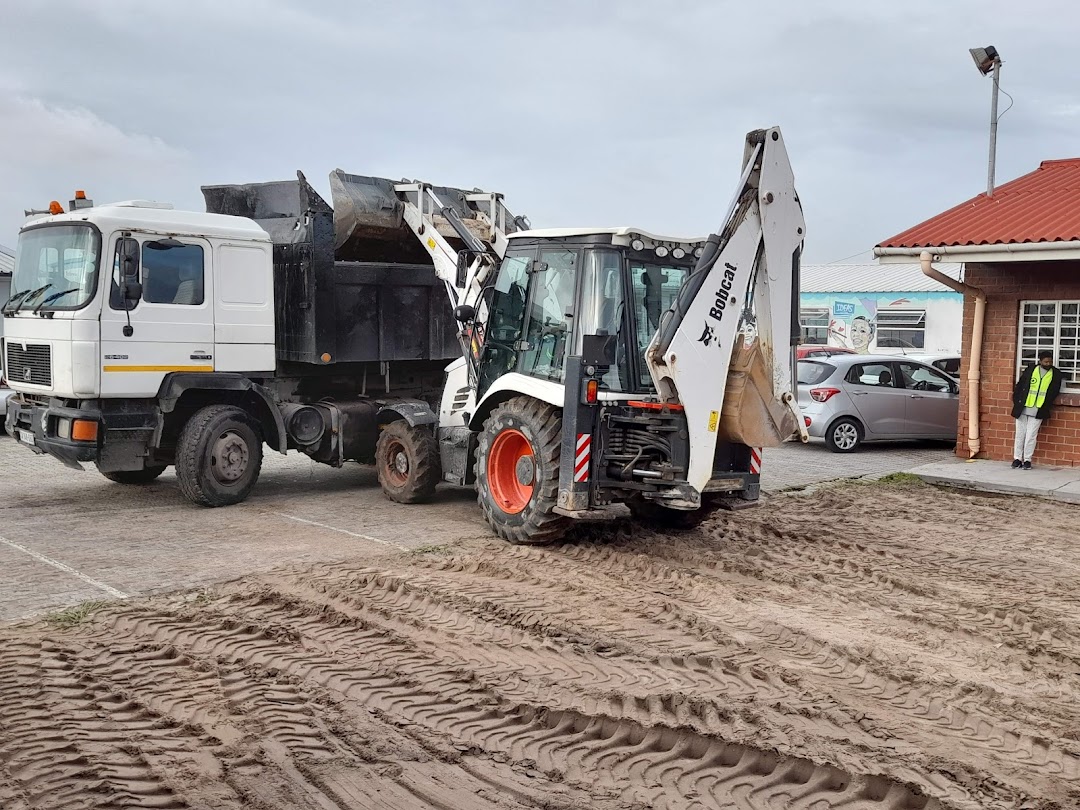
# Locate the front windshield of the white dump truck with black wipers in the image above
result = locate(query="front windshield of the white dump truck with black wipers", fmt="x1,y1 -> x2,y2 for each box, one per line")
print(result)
4,224 -> 102,312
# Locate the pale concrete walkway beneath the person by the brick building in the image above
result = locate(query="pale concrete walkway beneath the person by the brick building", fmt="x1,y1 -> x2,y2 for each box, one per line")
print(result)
907,459 -> 1080,503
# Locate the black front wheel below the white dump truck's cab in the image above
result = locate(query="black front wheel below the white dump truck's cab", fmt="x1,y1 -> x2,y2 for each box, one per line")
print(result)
176,405 -> 262,507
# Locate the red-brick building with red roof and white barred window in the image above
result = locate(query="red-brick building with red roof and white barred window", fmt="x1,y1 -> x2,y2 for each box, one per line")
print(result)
875,159 -> 1080,467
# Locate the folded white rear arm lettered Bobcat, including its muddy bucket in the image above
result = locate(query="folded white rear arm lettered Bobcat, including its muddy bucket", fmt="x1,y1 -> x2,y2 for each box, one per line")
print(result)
646,127 -> 805,492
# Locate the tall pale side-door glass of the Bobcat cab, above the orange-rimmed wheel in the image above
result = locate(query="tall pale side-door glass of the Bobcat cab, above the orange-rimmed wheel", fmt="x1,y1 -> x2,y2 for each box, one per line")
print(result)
522,249 -> 578,380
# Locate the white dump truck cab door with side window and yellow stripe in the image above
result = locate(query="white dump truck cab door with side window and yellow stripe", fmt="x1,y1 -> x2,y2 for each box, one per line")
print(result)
102,237 -> 214,396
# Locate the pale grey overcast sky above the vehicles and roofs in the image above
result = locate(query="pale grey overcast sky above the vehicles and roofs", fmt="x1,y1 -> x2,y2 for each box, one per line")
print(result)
0,0 -> 1080,262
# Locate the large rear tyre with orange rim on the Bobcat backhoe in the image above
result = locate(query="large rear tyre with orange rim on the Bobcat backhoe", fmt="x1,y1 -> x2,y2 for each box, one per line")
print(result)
476,396 -> 570,545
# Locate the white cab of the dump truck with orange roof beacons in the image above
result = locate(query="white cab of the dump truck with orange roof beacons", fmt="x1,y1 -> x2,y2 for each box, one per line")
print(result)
3,201 -> 274,473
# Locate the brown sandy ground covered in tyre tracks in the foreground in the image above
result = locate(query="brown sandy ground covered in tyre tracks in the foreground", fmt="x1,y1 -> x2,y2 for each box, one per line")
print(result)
0,484 -> 1080,810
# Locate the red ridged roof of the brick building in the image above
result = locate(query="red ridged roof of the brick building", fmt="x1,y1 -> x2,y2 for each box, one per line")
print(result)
878,158 -> 1080,247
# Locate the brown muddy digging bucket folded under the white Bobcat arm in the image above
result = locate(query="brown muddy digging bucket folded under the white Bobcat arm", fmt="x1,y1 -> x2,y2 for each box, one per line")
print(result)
719,339 -> 798,447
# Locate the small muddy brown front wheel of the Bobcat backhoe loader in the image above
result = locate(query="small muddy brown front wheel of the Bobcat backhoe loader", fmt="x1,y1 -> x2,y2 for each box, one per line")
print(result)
375,419 -> 442,503
